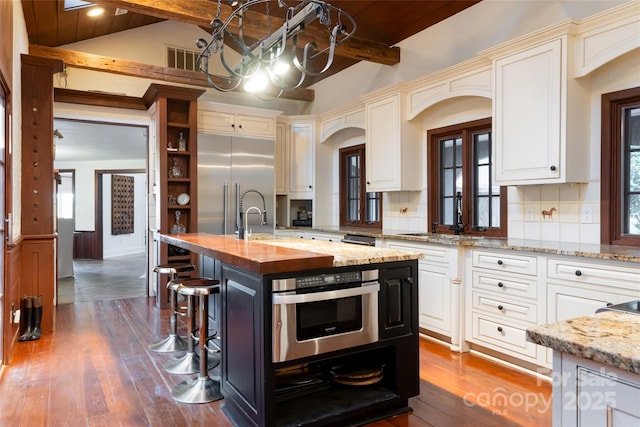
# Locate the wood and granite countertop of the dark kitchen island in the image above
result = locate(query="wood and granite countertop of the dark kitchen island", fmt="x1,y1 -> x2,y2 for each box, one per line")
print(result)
160,233 -> 422,274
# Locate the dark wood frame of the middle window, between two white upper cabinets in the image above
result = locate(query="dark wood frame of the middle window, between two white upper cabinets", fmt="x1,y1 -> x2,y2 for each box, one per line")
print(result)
427,117 -> 508,237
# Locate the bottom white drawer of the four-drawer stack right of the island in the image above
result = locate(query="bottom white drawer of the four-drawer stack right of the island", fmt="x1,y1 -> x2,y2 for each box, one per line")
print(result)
472,313 -> 537,358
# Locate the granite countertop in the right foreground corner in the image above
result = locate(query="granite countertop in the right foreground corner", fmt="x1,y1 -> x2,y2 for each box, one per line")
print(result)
527,311 -> 640,374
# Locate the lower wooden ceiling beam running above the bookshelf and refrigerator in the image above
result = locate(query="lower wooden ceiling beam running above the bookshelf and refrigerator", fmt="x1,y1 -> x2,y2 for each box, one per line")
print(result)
29,45 -> 315,101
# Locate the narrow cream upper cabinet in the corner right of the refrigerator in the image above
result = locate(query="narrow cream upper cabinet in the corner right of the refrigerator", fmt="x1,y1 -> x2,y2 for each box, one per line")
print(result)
288,122 -> 315,199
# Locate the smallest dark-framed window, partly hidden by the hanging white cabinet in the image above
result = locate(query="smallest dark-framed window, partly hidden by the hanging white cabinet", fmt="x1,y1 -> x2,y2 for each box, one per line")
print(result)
340,144 -> 382,228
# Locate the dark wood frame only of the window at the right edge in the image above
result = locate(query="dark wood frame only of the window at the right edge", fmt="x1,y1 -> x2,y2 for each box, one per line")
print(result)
600,87 -> 640,246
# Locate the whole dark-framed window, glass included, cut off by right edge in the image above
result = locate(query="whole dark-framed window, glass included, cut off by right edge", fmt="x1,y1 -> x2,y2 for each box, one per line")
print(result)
600,87 -> 640,246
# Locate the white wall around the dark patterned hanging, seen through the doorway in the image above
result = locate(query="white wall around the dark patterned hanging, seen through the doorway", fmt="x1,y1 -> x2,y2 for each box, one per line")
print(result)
102,173 -> 147,259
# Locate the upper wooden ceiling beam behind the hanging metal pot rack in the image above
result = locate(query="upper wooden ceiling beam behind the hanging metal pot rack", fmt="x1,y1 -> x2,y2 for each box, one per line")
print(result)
95,0 -> 400,65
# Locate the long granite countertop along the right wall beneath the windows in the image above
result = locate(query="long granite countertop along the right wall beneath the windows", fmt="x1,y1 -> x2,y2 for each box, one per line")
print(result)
282,226 -> 640,263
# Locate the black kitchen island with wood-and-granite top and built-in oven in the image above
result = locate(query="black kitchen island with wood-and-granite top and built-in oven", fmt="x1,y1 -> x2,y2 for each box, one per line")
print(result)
160,233 -> 421,426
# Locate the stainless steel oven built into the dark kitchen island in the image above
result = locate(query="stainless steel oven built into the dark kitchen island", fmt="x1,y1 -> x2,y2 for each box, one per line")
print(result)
272,270 -> 380,363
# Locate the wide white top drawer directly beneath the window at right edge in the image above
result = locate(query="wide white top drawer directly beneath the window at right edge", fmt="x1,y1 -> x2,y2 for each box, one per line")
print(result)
547,258 -> 640,290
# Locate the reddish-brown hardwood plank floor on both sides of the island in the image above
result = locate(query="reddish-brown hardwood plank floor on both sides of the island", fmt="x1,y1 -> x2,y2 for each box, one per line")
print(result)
0,297 -> 551,427
